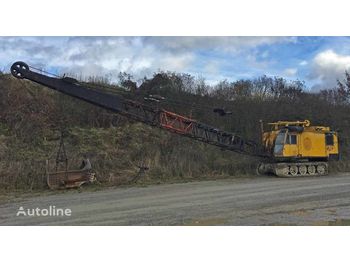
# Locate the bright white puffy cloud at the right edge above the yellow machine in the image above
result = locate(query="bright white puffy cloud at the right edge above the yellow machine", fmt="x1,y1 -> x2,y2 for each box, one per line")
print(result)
309,49 -> 350,90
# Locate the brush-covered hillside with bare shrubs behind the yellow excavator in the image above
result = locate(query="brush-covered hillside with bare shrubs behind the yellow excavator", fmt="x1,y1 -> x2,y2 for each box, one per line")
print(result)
0,74 -> 350,190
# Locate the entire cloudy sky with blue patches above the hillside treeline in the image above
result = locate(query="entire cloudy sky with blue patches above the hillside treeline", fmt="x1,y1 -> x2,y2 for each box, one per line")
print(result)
0,37 -> 350,90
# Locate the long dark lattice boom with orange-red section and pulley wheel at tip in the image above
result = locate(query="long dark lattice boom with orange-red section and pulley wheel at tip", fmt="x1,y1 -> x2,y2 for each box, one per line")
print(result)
11,62 -> 263,156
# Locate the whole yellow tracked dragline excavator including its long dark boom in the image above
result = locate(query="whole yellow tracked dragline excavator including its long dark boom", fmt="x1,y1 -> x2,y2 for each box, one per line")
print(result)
11,62 -> 339,177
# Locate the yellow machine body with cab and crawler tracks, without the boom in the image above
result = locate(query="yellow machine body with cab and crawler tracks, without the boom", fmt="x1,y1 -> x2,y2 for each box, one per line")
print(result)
257,120 -> 339,177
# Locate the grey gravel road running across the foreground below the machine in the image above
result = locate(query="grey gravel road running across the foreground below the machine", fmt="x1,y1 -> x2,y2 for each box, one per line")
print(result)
0,174 -> 350,225
